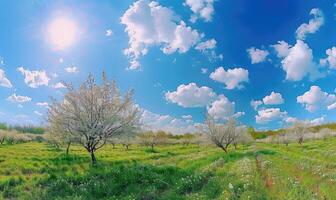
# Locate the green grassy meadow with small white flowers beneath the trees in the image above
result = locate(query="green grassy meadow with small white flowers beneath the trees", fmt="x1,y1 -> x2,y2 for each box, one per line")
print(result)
0,139 -> 336,200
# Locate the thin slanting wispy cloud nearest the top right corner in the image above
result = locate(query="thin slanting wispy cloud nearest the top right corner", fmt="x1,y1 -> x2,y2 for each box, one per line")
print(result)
296,8 -> 324,40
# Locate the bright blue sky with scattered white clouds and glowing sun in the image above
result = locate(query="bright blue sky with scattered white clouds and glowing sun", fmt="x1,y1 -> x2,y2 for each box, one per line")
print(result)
0,0 -> 336,133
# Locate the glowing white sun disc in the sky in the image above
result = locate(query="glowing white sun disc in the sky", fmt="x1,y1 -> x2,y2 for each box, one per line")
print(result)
47,17 -> 79,50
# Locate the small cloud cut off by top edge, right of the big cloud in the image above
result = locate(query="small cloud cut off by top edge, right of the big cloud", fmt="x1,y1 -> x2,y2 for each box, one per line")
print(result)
185,0 -> 215,23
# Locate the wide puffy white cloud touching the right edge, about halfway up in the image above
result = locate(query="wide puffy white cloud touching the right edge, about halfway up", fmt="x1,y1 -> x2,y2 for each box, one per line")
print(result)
296,85 -> 336,112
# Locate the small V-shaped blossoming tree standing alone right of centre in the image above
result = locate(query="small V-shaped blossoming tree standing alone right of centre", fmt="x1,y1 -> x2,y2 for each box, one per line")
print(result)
205,115 -> 237,153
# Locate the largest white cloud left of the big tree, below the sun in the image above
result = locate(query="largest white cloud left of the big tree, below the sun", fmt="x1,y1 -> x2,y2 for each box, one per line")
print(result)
17,67 -> 50,88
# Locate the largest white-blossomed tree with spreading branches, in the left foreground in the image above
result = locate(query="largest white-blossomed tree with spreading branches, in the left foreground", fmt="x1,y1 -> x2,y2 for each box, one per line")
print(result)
48,72 -> 139,164
